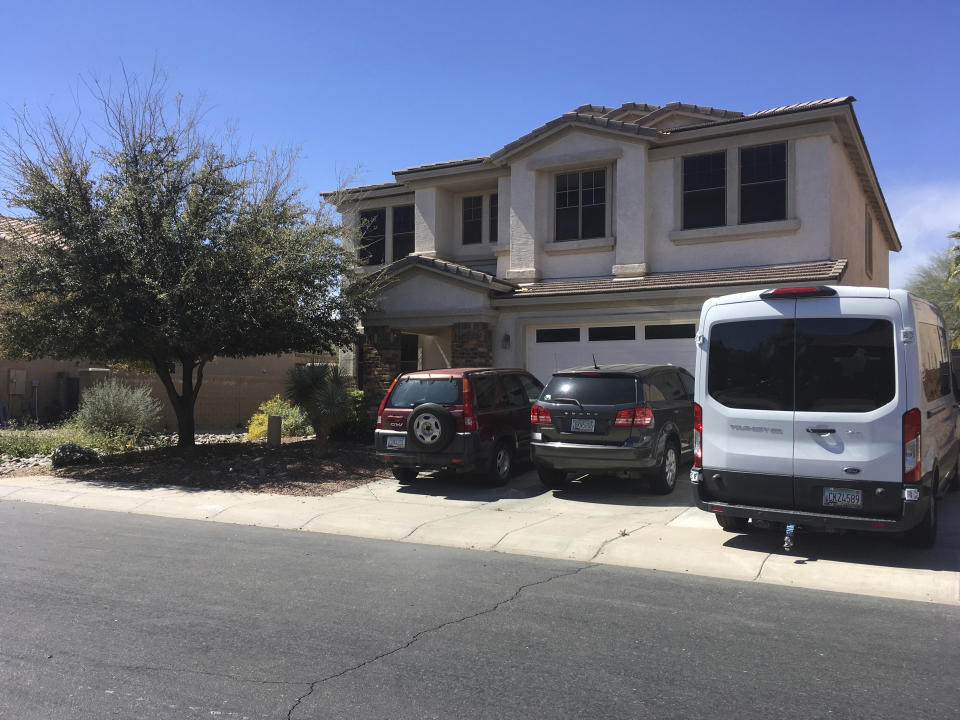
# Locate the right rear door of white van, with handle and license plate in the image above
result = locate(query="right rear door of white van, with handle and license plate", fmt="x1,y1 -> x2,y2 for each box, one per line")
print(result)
793,297 -> 907,517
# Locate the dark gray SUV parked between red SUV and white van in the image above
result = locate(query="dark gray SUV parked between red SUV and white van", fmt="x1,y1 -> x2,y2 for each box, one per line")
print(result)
530,365 -> 693,495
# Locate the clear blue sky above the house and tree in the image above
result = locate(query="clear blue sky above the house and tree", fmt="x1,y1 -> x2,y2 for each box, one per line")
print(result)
0,0 -> 960,286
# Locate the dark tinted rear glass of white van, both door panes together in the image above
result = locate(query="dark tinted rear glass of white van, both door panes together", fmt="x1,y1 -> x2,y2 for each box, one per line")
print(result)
707,318 -> 896,412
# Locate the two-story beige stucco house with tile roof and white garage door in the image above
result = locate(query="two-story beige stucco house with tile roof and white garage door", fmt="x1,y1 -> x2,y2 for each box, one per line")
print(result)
328,97 -> 900,396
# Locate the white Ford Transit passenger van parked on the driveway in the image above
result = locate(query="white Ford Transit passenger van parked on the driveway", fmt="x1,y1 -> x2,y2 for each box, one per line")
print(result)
691,286 -> 960,547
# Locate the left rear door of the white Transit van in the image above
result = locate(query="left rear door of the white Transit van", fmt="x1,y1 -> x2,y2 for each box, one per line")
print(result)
697,298 -> 796,508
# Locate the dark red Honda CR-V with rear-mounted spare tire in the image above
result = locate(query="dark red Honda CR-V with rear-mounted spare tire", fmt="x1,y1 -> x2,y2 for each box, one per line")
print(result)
376,368 -> 543,485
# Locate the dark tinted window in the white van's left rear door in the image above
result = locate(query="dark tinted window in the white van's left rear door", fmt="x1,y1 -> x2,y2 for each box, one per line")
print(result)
707,319 -> 794,410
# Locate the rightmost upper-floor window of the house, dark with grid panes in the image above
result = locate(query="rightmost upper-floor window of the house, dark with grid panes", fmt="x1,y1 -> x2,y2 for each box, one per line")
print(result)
740,143 -> 787,223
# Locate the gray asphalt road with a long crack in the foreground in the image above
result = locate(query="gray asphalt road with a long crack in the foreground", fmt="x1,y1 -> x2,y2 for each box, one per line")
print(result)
0,502 -> 960,720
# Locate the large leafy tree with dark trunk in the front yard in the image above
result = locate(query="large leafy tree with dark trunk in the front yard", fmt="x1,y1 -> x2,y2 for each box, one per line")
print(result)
0,70 -> 377,446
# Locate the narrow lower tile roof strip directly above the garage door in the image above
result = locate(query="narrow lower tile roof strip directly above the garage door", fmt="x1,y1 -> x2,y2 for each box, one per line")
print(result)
500,258 -> 847,298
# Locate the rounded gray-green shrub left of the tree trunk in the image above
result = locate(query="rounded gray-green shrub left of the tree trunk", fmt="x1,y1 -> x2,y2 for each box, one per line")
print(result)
72,378 -> 160,446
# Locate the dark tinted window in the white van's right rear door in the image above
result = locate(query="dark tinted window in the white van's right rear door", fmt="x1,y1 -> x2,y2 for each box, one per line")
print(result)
797,318 -> 896,412
